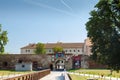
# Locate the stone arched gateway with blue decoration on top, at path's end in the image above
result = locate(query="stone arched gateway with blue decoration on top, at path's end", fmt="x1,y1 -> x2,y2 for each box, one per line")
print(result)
50,51 -> 72,71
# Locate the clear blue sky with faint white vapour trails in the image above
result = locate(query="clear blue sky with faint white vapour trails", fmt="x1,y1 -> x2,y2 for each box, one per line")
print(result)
0,0 -> 98,54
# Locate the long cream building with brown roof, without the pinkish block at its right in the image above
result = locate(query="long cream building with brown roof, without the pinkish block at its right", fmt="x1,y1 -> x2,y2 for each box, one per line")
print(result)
21,42 -> 84,55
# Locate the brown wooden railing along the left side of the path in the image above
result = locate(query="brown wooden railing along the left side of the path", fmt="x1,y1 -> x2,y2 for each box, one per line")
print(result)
2,69 -> 50,80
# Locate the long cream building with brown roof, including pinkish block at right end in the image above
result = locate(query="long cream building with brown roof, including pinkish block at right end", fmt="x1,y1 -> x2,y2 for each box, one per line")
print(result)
21,38 -> 91,55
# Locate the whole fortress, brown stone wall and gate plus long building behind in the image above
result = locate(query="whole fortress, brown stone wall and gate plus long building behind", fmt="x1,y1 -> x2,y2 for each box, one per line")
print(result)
0,39 -> 104,70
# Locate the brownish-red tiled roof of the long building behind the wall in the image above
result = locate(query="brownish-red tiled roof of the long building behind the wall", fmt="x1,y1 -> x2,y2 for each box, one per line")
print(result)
21,43 -> 84,49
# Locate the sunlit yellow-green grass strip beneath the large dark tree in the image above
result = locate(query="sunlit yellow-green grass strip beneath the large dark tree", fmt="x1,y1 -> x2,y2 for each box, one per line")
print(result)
69,69 -> 120,78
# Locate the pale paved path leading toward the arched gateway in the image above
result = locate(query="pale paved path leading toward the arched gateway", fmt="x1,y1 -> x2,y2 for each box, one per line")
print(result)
40,71 -> 64,80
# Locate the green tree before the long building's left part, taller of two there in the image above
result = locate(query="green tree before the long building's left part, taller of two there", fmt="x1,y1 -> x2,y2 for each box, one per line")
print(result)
35,43 -> 46,54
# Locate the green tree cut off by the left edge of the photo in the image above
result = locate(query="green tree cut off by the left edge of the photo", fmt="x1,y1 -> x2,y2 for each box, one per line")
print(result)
0,24 -> 8,54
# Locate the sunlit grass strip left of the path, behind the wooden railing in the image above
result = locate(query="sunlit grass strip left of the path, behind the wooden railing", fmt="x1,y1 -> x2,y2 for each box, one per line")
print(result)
0,70 -> 33,76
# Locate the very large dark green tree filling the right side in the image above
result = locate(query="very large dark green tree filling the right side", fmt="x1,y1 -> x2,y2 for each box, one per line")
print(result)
86,0 -> 120,71
